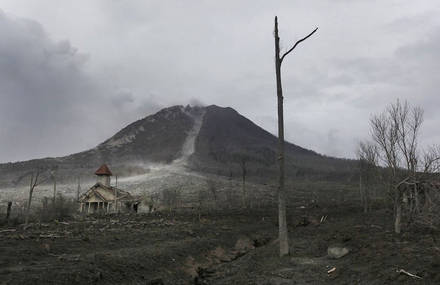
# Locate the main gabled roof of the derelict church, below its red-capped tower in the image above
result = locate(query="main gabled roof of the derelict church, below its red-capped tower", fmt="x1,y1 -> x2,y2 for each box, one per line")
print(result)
79,182 -> 138,203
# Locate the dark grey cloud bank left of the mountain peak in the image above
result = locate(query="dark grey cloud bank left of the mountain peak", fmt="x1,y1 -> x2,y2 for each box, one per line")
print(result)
0,11 -> 160,161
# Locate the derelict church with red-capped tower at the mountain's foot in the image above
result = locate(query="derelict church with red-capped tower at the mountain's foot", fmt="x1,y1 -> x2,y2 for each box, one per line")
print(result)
79,164 -> 139,214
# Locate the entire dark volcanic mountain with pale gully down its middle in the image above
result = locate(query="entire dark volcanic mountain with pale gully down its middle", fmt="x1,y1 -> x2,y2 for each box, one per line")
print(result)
0,105 -> 353,187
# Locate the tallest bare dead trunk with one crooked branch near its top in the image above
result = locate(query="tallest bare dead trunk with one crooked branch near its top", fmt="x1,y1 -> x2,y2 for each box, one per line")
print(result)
274,16 -> 318,256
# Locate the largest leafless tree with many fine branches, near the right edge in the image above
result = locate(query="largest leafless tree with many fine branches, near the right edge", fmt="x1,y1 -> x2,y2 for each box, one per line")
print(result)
370,100 -> 440,233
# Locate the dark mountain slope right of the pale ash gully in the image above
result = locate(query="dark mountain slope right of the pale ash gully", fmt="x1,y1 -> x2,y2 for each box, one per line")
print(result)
194,105 -> 354,179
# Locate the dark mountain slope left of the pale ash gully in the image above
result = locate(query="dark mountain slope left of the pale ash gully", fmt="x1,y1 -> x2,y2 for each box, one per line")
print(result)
67,106 -> 203,166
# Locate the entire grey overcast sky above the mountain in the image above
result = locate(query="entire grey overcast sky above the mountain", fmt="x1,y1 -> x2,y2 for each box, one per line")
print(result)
0,0 -> 440,162
